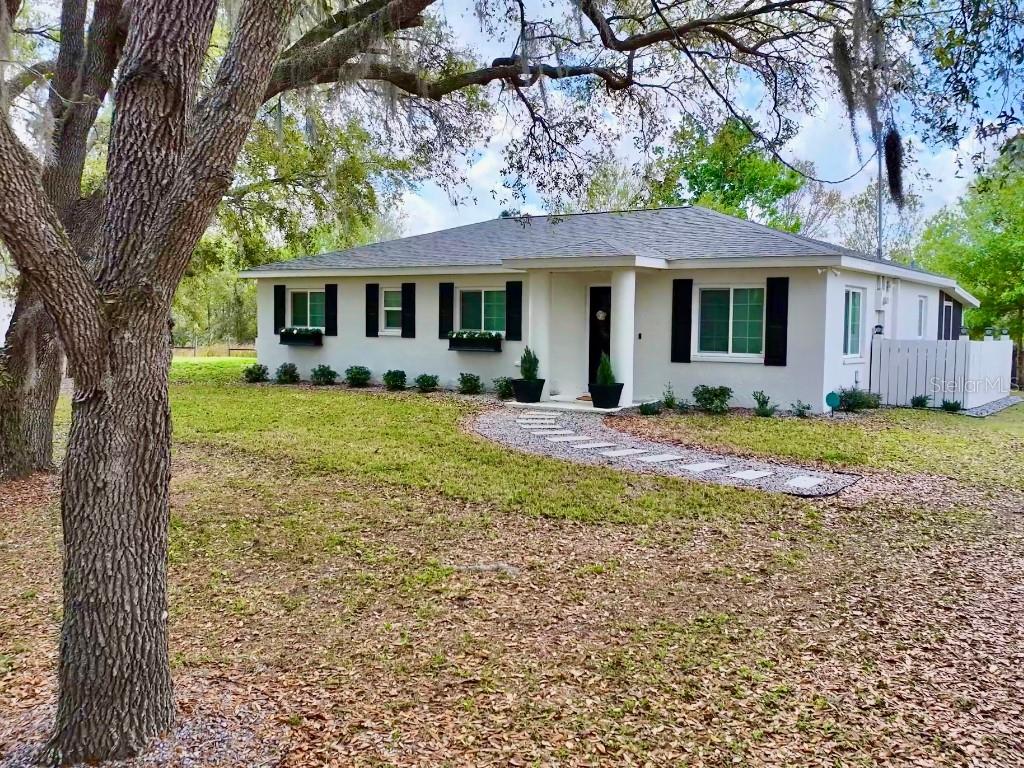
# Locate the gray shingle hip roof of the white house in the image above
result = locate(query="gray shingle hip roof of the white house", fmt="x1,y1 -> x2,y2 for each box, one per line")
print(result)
245,206 -> 864,271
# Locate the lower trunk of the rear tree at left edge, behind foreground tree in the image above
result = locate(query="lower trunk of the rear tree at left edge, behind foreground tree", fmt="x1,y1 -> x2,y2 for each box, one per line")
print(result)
0,282 -> 63,479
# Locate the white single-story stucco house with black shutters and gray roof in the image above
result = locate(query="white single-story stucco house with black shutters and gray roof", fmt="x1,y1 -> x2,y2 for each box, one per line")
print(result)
244,207 -> 978,410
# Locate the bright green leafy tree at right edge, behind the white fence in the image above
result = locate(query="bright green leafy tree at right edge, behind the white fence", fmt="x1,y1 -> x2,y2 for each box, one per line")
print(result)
915,157 -> 1024,371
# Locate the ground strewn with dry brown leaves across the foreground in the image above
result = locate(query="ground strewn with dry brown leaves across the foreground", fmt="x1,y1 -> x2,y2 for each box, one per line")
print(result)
0,393 -> 1024,766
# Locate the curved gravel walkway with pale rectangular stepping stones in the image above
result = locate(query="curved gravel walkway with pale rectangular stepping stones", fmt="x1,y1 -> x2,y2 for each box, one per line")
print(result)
475,407 -> 860,496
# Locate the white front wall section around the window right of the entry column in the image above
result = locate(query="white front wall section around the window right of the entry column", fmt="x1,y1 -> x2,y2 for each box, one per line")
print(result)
634,267 -> 827,410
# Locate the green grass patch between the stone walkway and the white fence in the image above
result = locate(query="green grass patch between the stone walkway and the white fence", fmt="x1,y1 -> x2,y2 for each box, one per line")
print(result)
622,403 -> 1024,487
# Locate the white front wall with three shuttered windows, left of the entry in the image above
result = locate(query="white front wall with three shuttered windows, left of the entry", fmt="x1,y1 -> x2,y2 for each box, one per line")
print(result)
256,274 -> 528,388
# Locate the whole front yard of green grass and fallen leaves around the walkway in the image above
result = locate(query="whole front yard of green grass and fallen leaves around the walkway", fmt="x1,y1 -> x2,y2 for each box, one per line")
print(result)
16,359 -> 1024,768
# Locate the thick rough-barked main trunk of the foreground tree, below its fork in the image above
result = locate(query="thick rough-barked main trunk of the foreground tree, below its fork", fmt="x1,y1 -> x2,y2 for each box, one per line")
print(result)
49,309 -> 173,764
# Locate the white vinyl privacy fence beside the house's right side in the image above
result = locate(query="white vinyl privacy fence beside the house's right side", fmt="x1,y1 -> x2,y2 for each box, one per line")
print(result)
869,336 -> 1013,409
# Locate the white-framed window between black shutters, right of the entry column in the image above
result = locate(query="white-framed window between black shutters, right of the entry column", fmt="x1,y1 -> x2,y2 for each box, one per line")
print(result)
697,286 -> 765,355
